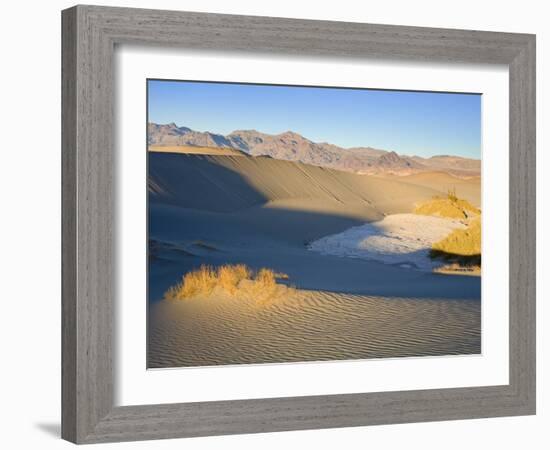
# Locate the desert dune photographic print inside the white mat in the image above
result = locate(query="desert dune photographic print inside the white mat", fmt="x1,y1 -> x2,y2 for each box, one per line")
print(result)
146,79 -> 482,368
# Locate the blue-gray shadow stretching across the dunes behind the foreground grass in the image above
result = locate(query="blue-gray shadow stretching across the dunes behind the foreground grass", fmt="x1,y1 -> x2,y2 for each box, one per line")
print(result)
148,153 -> 481,301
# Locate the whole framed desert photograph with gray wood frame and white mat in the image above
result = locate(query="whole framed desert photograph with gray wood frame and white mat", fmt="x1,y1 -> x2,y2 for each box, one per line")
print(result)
62,6 -> 535,443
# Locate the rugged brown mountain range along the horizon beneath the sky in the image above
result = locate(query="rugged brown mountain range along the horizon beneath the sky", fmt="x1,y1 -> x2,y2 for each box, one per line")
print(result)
147,123 -> 481,177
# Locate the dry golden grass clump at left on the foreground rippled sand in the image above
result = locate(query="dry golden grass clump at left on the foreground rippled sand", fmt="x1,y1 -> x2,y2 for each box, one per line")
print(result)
164,264 -> 290,301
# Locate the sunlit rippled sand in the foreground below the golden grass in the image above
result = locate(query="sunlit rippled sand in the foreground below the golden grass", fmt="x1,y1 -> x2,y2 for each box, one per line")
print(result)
148,291 -> 481,368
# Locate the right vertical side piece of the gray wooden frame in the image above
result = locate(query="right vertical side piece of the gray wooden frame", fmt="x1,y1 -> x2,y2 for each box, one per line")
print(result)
509,39 -> 536,410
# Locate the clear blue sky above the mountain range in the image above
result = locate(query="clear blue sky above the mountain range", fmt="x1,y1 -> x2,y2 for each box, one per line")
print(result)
148,80 -> 481,158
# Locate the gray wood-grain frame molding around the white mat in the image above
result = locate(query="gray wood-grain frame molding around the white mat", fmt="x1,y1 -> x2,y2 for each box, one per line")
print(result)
62,6 -> 535,443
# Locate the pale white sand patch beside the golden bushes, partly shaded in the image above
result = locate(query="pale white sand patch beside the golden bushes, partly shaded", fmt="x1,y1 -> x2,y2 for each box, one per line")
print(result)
309,214 -> 466,271
